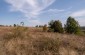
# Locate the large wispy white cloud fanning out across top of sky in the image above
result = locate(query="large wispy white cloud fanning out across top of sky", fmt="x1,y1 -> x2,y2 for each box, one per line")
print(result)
6,0 -> 56,23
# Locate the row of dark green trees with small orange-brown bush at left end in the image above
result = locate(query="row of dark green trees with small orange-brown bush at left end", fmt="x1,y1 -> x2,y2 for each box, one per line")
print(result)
43,17 -> 83,34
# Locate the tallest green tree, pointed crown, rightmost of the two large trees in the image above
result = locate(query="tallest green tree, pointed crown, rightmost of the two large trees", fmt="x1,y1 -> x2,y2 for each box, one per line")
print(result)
65,17 -> 80,34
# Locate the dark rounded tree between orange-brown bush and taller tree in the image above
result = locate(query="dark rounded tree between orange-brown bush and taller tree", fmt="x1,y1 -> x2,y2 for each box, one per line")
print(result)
49,20 -> 64,33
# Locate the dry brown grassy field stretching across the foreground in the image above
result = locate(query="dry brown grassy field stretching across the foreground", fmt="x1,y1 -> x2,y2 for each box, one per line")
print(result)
0,27 -> 85,55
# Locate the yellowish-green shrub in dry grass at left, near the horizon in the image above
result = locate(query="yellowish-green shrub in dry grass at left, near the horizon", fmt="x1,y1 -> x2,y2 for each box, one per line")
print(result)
7,26 -> 28,38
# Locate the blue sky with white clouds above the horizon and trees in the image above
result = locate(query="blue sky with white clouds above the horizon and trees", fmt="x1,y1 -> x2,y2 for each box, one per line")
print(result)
0,0 -> 85,26
